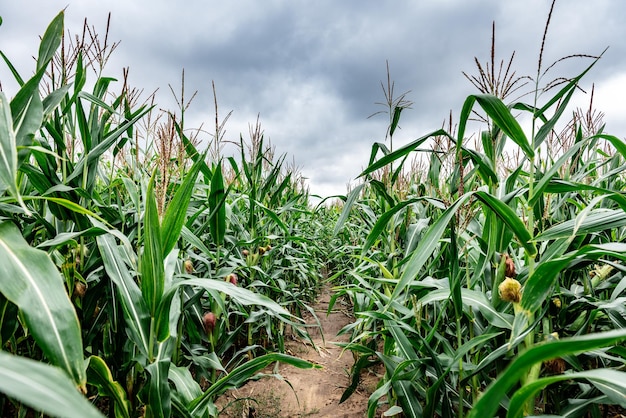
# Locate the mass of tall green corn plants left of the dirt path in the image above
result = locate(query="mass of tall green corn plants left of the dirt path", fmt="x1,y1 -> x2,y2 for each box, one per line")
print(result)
0,13 -> 331,417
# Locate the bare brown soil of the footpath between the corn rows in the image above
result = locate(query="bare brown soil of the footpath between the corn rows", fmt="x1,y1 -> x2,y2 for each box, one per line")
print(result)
218,287 -> 379,418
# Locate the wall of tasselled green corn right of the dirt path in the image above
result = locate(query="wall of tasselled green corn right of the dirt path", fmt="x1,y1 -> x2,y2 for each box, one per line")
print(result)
334,5 -> 626,417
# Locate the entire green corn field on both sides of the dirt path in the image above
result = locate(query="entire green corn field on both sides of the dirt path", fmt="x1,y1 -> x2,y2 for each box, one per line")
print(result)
0,8 -> 626,418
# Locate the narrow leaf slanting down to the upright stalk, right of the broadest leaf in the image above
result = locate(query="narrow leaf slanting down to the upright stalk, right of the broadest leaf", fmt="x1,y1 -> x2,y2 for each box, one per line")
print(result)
96,234 -> 151,358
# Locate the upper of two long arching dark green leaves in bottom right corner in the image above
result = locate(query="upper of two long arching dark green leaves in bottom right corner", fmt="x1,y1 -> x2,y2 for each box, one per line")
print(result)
468,329 -> 626,418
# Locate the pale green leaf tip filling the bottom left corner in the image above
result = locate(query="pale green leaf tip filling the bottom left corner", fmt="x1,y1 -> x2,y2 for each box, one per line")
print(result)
0,350 -> 104,418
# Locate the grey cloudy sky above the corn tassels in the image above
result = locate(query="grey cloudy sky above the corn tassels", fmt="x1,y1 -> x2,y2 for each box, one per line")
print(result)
0,0 -> 626,196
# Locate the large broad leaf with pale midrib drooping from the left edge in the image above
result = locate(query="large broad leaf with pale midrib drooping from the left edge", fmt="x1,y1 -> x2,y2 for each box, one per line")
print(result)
0,222 -> 87,388
